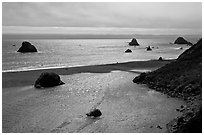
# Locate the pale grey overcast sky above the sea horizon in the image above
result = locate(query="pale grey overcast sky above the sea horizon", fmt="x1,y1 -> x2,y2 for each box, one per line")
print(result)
2,2 -> 202,34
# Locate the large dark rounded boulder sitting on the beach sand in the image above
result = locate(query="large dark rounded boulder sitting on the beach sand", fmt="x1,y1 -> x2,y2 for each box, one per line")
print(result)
35,72 -> 65,88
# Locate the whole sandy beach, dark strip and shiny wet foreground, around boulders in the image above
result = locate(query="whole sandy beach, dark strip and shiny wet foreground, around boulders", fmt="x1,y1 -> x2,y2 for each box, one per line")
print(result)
2,61 -> 185,133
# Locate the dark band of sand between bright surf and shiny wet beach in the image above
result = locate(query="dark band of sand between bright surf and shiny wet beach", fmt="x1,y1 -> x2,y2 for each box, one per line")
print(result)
2,60 -> 173,88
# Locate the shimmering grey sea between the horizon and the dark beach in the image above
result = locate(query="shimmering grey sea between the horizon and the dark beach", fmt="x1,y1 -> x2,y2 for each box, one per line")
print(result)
2,38 -> 197,71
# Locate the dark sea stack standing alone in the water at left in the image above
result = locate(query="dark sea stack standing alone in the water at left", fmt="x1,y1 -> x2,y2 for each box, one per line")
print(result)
17,41 -> 37,53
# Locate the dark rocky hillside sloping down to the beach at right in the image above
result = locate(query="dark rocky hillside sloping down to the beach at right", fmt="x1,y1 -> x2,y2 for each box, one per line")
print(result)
133,39 -> 202,132
